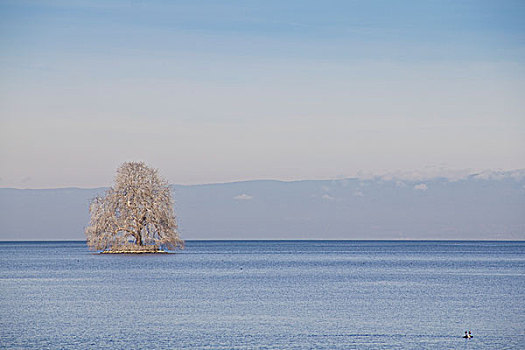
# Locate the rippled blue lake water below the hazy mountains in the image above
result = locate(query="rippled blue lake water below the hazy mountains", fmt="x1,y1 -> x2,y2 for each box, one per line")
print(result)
0,241 -> 525,349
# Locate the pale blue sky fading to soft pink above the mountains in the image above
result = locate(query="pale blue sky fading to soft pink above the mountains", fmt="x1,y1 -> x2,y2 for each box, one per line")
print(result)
0,0 -> 525,188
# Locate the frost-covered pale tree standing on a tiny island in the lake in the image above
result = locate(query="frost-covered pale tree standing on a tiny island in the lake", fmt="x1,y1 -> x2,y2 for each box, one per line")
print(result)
86,162 -> 184,251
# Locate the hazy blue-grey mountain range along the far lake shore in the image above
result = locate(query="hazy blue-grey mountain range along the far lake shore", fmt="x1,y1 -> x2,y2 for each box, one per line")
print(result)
0,170 -> 525,240
